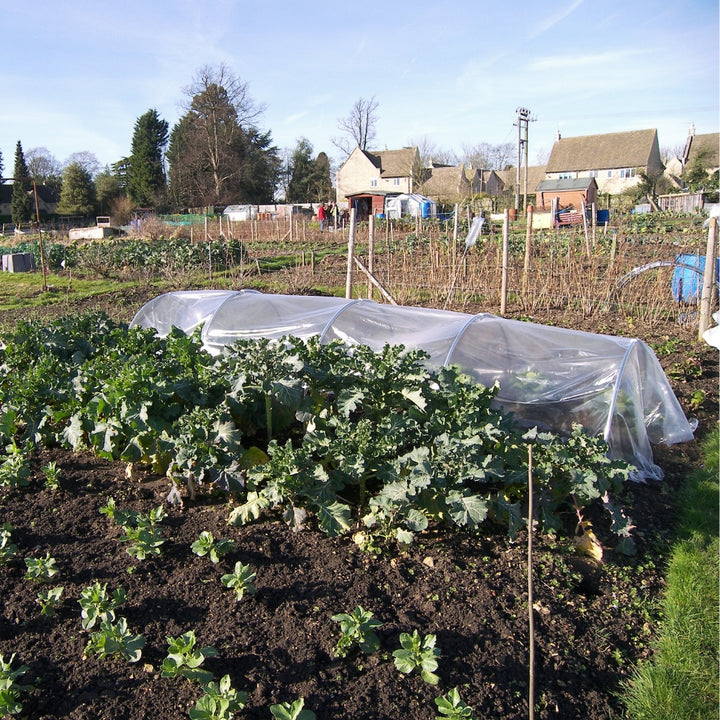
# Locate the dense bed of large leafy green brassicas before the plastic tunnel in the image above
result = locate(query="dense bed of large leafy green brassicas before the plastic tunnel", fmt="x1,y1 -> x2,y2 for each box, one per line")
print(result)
0,314 -> 632,559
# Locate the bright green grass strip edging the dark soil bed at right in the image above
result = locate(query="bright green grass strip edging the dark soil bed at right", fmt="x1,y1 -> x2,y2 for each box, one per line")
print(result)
623,430 -> 720,720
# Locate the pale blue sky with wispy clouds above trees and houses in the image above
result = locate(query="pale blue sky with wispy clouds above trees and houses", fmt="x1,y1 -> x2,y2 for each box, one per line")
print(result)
0,0 -> 720,175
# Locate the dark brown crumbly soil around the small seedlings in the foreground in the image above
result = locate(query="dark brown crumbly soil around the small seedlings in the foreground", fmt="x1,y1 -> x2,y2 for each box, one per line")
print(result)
0,286 -> 717,720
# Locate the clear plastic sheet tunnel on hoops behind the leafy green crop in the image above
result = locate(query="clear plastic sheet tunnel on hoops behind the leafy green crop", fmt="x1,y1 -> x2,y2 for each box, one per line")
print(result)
131,290 -> 694,479
